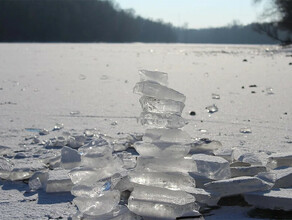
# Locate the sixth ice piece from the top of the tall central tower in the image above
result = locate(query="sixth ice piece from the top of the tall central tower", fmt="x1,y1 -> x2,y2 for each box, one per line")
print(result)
134,141 -> 191,158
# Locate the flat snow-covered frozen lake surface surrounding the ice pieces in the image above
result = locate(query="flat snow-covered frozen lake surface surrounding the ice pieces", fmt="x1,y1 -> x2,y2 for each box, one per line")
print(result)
0,44 -> 292,219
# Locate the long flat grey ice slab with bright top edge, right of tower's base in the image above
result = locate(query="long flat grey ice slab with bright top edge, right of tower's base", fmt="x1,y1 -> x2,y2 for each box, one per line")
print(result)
204,177 -> 271,197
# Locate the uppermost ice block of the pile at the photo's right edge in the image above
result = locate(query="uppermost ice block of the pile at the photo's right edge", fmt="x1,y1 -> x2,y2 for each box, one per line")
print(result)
267,152 -> 292,169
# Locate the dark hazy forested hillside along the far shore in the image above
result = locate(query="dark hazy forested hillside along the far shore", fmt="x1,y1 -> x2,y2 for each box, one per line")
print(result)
0,0 -> 288,44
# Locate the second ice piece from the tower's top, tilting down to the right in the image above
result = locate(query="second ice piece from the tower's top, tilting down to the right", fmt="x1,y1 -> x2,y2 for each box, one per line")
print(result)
134,81 -> 186,103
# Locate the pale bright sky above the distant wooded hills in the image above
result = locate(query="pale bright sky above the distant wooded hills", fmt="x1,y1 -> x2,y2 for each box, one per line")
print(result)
115,0 -> 267,29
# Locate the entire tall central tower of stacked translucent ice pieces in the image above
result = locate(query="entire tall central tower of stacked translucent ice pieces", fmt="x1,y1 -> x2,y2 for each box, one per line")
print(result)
128,70 -> 199,219
